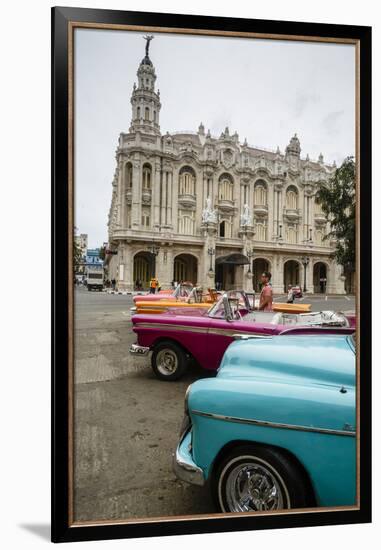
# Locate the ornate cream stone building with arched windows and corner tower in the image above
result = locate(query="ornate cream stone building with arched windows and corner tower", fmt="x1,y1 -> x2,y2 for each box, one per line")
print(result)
106,37 -> 345,293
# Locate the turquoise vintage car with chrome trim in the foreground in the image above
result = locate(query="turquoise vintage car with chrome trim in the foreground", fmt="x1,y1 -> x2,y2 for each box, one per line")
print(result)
173,335 -> 356,512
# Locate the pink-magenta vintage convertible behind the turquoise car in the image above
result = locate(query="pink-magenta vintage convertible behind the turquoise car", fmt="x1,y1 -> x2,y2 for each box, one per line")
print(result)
130,292 -> 356,380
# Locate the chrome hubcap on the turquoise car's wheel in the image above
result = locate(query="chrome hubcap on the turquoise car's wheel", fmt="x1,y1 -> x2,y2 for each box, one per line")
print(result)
226,462 -> 284,512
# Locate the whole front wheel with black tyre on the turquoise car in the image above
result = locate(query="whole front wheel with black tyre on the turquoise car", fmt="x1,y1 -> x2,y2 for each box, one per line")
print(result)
212,445 -> 311,512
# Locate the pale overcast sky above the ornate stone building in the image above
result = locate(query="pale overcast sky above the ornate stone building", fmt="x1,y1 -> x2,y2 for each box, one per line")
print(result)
74,29 -> 355,247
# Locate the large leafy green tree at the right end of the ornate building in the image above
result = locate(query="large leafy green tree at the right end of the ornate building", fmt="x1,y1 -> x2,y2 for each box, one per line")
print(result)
316,157 -> 356,268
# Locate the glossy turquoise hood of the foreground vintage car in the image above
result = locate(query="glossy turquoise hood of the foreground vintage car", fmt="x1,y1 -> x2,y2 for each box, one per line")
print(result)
217,335 -> 355,387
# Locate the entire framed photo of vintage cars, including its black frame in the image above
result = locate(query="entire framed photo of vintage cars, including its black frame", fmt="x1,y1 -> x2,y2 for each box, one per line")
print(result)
52,4 -> 371,542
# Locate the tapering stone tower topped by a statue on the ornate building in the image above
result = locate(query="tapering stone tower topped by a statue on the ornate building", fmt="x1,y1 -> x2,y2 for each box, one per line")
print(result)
130,35 -> 161,135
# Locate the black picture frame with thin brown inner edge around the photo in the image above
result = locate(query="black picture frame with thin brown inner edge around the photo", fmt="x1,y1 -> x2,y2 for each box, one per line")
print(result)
51,7 -> 371,542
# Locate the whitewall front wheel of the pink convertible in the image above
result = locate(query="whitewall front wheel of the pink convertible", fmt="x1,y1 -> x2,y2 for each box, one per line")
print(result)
151,342 -> 188,381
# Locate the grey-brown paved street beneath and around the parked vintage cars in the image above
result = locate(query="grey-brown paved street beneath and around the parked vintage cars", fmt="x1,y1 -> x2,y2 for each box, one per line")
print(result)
74,288 -> 355,520
